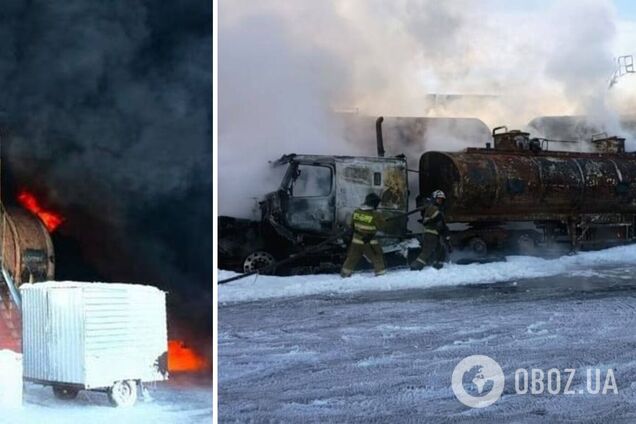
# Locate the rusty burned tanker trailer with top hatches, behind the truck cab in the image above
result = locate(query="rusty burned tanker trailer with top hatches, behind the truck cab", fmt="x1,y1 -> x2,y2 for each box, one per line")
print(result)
419,127 -> 636,252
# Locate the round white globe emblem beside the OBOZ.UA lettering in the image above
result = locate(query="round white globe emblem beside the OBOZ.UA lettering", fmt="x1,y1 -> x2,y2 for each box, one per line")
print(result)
452,355 -> 505,408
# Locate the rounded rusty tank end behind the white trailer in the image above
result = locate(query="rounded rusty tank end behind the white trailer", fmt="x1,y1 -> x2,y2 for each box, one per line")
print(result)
0,207 -> 55,285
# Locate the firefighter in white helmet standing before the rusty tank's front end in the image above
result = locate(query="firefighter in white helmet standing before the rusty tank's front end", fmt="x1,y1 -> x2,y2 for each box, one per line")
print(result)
411,190 -> 450,271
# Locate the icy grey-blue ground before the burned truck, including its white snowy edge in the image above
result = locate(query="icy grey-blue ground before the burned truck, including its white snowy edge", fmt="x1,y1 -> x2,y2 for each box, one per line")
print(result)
219,246 -> 636,423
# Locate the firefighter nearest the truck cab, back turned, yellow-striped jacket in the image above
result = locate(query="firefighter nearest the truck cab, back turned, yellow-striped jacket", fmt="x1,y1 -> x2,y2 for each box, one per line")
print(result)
340,193 -> 386,278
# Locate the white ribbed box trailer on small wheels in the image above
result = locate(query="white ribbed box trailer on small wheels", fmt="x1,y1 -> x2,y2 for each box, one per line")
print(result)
20,282 -> 168,406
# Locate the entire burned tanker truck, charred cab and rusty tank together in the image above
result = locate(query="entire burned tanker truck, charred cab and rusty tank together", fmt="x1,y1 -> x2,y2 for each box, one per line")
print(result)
219,118 -> 636,272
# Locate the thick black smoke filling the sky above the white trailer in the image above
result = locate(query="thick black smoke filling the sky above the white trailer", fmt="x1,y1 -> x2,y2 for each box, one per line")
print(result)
0,0 -> 212,344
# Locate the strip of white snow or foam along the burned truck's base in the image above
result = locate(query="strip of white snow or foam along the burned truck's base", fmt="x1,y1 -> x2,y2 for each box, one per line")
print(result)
218,245 -> 636,302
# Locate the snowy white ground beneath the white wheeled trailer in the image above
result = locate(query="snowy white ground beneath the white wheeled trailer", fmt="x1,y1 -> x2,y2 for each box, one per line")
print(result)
6,374 -> 212,424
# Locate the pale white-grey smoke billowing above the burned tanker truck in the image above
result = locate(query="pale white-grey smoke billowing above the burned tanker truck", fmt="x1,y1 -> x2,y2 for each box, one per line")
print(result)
218,0 -> 623,216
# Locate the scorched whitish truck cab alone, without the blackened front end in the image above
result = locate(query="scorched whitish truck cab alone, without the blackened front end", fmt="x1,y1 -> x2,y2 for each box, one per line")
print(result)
261,155 -> 408,242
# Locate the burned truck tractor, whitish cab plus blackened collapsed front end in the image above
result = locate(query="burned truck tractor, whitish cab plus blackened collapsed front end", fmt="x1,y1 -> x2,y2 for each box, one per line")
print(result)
219,154 -> 409,272
